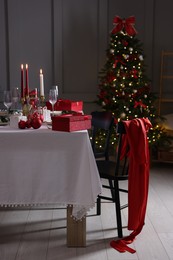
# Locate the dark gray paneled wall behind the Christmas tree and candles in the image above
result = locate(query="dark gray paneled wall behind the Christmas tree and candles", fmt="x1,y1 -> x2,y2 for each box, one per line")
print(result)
0,0 -> 173,112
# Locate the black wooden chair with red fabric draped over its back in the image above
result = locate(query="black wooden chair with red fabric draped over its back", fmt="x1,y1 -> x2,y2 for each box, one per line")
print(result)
92,112 -> 128,237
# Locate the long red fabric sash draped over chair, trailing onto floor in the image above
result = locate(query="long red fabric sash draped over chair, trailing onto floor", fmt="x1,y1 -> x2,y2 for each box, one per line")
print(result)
110,118 -> 152,253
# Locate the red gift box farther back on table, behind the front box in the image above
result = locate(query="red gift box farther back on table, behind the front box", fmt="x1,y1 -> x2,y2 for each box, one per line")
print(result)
46,99 -> 83,111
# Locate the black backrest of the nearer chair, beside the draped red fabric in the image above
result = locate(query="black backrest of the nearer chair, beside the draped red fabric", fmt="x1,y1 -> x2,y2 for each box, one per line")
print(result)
115,121 -> 129,179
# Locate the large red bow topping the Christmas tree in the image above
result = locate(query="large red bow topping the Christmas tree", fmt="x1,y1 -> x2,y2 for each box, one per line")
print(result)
112,16 -> 137,36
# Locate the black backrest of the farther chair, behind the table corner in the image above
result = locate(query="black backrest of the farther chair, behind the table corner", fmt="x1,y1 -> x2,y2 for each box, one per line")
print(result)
91,111 -> 114,160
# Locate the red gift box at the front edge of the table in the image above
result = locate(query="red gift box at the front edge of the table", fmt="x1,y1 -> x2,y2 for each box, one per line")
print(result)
52,114 -> 91,132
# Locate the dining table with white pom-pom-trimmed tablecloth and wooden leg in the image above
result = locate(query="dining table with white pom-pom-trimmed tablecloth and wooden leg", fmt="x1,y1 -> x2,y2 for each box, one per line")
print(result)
0,124 -> 102,247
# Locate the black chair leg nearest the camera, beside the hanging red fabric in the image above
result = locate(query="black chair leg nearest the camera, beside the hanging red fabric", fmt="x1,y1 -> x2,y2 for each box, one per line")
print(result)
114,180 -> 123,238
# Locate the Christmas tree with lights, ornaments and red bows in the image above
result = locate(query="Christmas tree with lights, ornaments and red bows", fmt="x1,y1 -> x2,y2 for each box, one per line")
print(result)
97,16 -> 171,152
